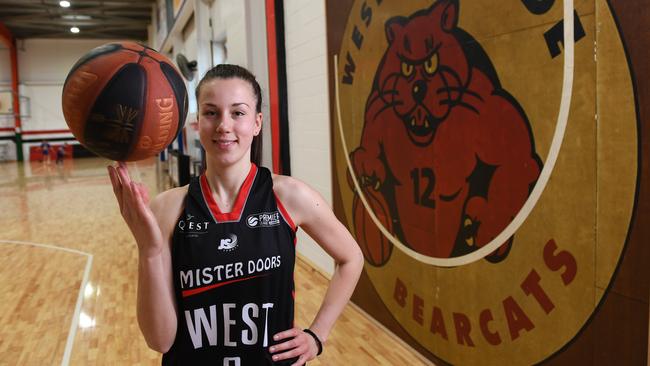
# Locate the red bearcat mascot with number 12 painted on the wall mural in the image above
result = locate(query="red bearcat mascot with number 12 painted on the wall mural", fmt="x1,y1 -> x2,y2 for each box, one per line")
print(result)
351,0 -> 542,266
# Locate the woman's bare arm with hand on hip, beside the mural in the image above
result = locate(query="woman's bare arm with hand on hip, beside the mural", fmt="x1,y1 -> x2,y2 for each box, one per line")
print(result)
271,176 -> 363,365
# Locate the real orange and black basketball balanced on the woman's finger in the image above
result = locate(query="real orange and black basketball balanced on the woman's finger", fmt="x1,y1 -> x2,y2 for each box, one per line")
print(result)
62,42 -> 187,161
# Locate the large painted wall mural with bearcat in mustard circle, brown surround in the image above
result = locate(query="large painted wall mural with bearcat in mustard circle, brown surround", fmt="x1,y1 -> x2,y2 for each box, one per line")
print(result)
327,0 -> 650,365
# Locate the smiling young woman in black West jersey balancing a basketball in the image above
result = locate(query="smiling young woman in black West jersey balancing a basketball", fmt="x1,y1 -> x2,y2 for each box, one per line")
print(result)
108,65 -> 363,366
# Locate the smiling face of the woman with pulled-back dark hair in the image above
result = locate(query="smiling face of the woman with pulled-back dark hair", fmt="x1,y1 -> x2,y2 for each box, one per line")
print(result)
198,78 -> 262,166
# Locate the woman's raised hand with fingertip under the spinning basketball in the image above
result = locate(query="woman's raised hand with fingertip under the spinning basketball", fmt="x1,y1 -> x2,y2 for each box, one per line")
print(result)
108,162 -> 164,257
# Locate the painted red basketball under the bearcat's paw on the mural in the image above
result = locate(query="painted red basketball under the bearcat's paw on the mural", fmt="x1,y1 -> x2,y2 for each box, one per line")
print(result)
352,189 -> 393,266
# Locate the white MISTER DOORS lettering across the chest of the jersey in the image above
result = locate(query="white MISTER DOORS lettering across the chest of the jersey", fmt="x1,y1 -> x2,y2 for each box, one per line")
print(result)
179,255 -> 281,289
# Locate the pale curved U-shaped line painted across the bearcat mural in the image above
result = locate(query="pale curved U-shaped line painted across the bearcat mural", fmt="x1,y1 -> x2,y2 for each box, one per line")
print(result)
334,0 -> 575,267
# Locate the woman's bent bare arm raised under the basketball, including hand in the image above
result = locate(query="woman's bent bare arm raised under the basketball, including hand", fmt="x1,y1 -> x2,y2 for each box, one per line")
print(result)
108,163 -> 186,353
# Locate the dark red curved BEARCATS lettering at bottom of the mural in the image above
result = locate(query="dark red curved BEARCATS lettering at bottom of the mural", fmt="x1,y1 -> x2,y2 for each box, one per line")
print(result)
393,239 -> 578,347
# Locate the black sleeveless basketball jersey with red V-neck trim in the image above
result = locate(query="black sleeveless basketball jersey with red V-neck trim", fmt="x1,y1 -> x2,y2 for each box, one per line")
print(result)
162,164 -> 296,366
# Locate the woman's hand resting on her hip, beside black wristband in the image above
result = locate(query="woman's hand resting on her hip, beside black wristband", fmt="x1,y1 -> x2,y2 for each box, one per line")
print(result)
269,327 -> 318,366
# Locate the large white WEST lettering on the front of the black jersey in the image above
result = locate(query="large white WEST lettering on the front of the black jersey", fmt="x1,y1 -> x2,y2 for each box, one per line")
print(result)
184,302 -> 273,349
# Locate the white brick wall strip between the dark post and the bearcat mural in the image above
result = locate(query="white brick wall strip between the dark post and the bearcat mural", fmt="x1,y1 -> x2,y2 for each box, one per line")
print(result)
284,0 -> 334,274
